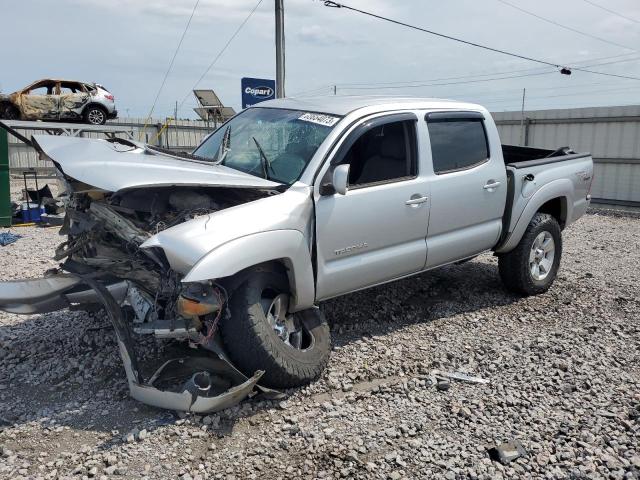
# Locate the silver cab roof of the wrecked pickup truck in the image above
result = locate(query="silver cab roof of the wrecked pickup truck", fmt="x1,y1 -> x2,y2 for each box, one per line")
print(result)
251,95 -> 483,116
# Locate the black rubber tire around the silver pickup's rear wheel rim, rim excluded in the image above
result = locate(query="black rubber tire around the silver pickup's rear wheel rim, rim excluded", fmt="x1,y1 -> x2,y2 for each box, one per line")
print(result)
498,213 -> 562,296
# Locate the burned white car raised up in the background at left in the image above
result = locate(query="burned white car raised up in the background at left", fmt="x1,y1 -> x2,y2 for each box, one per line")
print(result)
0,79 -> 118,125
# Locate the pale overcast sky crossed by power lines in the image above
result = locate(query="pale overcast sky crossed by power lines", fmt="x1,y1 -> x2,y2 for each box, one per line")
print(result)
0,0 -> 640,117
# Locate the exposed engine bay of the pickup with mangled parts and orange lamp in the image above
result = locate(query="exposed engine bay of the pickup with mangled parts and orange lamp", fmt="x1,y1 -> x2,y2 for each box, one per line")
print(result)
54,185 -> 267,333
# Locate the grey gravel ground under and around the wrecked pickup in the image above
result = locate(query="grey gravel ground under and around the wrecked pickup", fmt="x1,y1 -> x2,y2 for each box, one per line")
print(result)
0,214 -> 640,480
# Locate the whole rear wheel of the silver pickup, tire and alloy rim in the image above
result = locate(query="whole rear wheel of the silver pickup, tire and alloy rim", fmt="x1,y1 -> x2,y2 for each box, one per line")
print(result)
498,213 -> 562,296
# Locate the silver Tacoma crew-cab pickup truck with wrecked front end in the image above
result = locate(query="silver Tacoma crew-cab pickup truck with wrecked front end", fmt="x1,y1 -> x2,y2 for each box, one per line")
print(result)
0,96 -> 593,410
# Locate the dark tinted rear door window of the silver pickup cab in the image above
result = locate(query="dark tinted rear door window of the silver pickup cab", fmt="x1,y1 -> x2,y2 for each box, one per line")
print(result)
427,115 -> 489,175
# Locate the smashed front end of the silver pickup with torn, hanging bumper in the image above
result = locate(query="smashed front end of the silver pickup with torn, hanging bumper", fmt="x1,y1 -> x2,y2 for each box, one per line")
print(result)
0,138 -> 279,413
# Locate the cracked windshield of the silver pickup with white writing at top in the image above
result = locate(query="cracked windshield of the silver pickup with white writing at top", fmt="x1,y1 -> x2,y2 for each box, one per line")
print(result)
193,108 -> 340,185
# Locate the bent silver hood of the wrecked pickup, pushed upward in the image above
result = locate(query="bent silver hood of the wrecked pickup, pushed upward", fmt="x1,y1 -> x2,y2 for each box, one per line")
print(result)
33,135 -> 280,192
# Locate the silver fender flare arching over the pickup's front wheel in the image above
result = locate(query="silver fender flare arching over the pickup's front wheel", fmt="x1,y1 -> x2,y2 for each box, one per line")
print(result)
182,230 -> 315,311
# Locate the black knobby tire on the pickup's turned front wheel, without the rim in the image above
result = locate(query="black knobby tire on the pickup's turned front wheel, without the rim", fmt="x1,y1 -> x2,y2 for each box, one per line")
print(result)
221,270 -> 331,388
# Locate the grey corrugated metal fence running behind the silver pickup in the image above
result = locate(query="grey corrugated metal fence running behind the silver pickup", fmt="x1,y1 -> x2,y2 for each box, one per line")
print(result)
9,105 -> 640,205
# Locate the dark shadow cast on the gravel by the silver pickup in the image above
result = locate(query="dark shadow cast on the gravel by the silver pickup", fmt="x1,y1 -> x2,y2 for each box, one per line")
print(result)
0,256 -> 520,450
